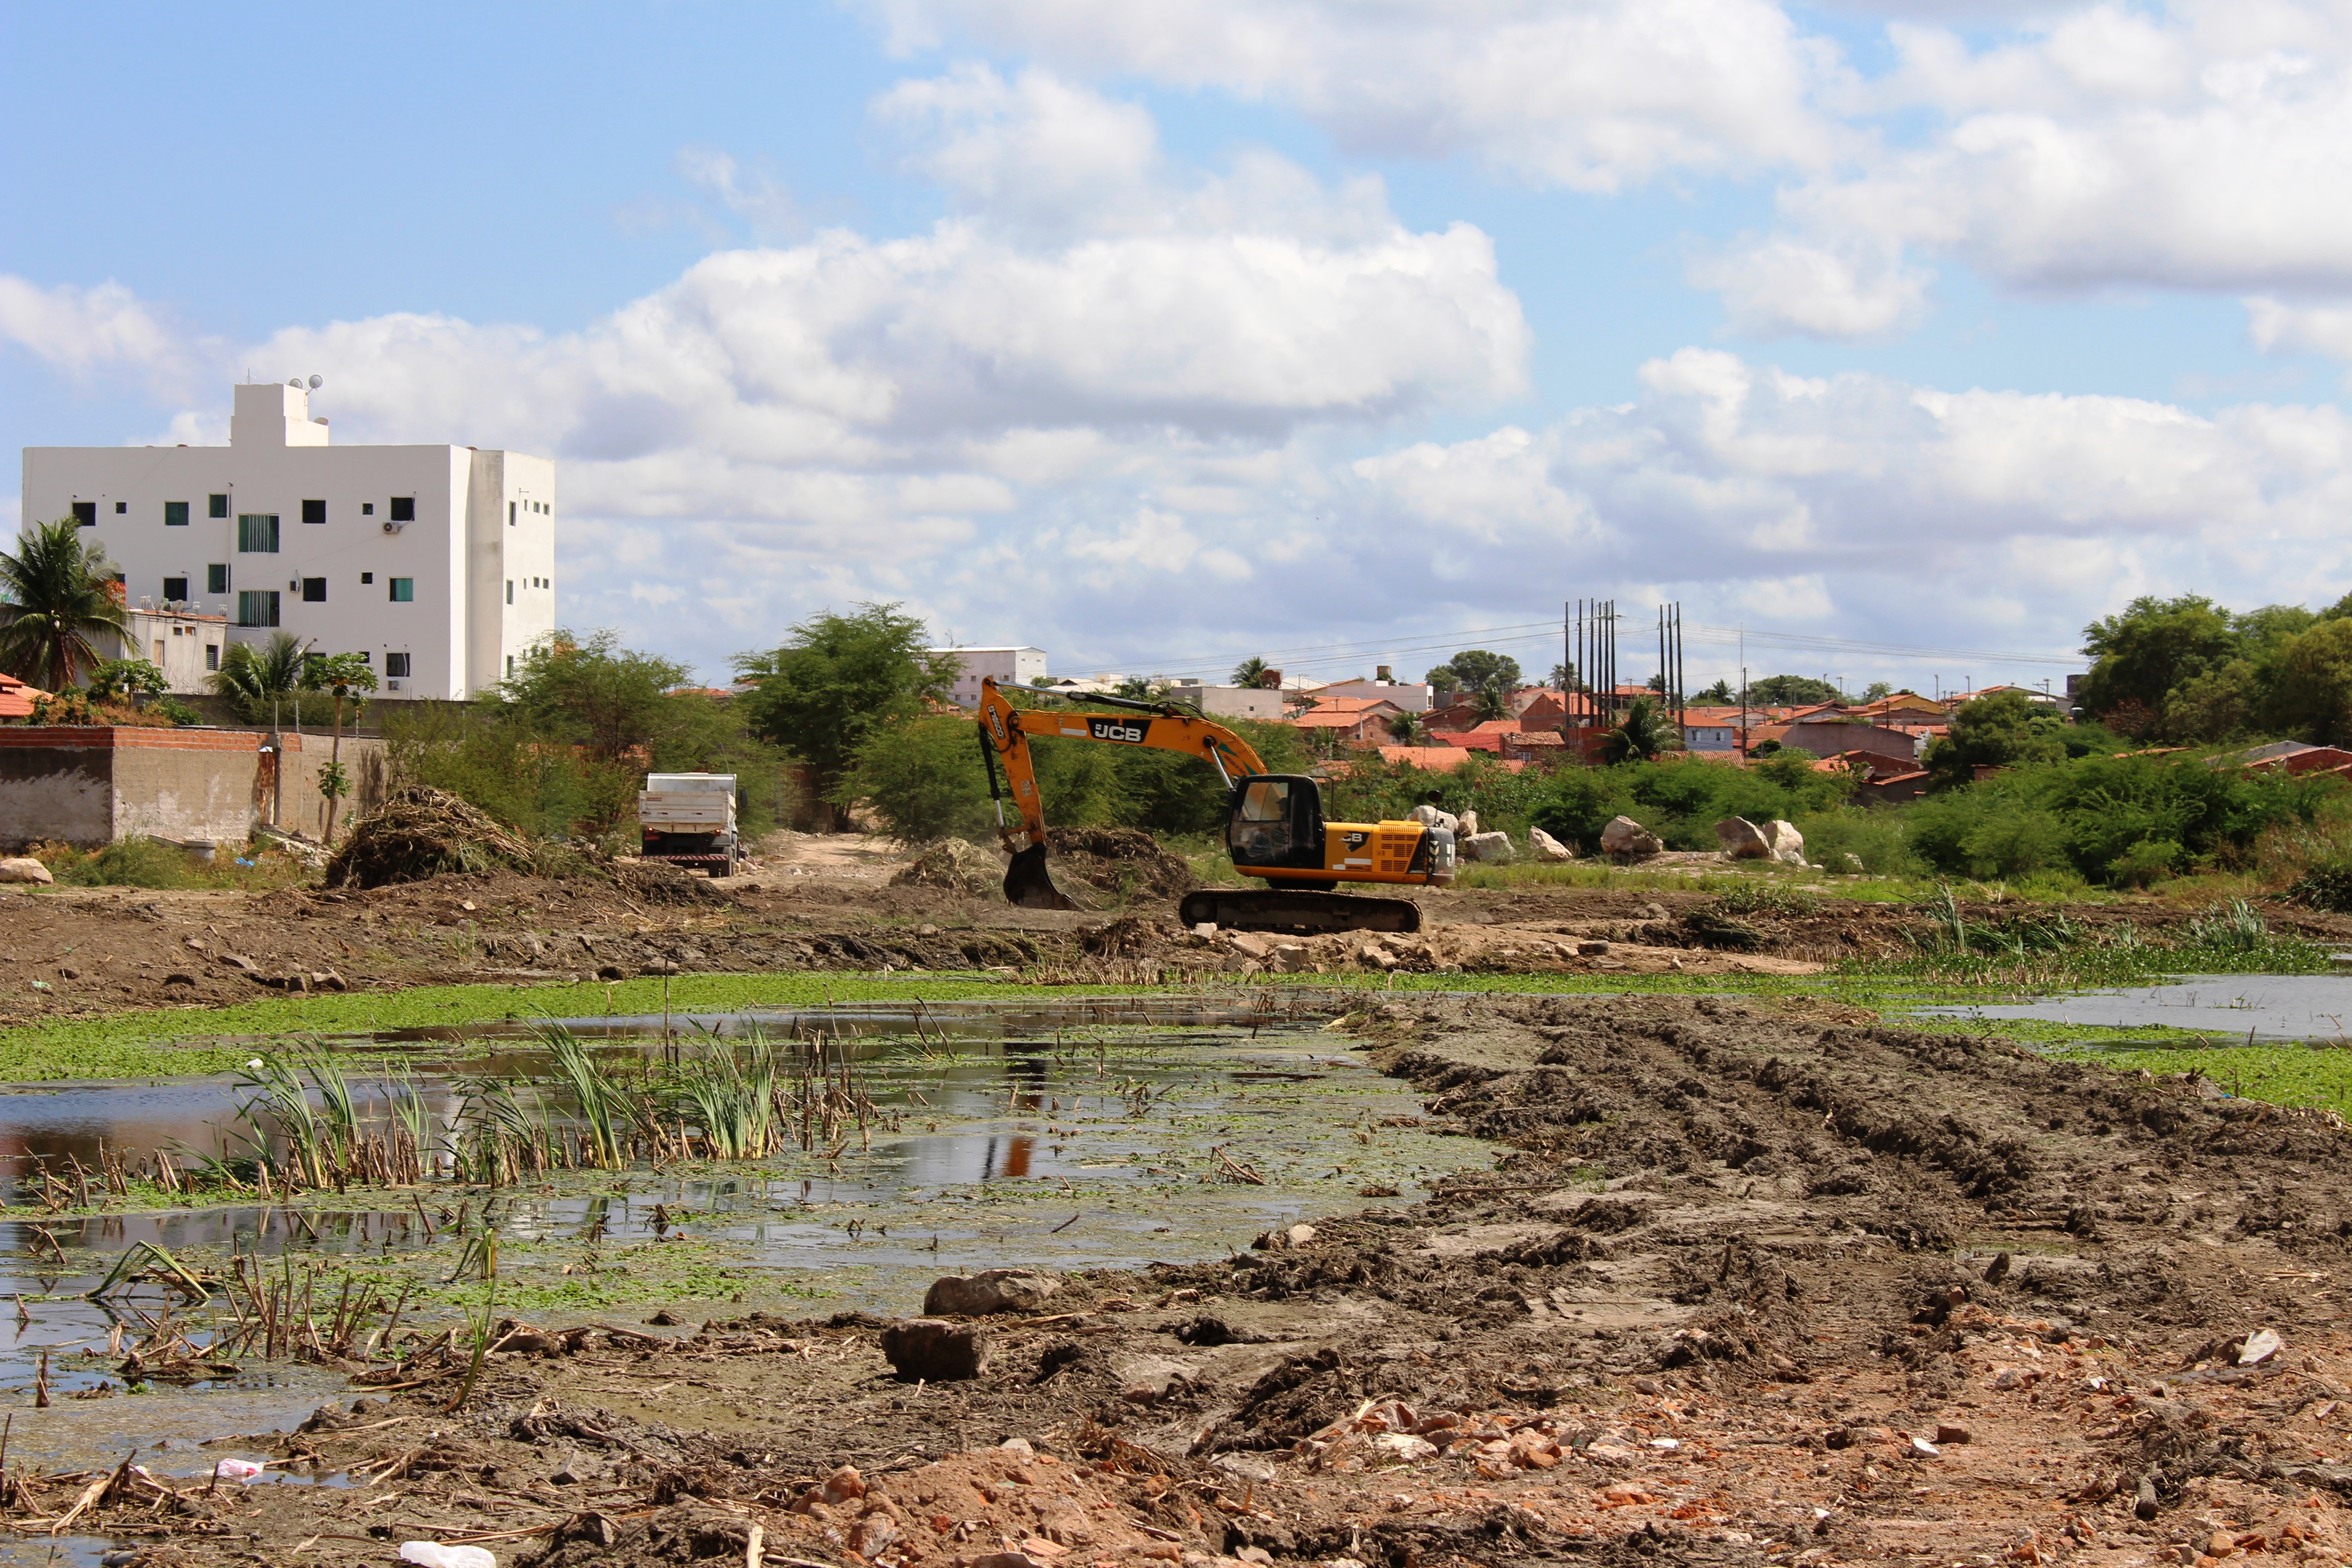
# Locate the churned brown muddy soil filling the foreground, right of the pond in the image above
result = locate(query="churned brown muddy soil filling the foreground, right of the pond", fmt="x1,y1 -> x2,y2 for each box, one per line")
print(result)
41,997 -> 2352,1568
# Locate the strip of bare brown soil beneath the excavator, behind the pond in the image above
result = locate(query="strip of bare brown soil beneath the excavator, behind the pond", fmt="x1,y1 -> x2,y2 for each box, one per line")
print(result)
0,834 -> 2352,1027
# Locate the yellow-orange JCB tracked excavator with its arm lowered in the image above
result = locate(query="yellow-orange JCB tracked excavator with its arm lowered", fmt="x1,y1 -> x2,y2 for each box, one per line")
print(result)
981,679 -> 1454,933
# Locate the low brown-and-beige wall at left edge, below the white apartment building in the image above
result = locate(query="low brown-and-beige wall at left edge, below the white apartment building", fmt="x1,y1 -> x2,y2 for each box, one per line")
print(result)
0,724 -> 386,848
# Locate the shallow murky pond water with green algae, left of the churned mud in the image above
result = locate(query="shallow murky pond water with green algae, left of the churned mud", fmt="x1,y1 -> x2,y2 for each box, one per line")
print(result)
0,1009 -> 1491,1474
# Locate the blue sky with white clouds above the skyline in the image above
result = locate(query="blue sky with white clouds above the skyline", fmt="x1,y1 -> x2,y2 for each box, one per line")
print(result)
14,0 -> 2352,686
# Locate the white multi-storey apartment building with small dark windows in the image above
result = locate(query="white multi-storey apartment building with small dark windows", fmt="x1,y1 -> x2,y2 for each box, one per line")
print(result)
21,376 -> 555,698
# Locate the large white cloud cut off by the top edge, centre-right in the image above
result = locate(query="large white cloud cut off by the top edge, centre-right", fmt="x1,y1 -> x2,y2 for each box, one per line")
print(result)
866,0 -> 1846,191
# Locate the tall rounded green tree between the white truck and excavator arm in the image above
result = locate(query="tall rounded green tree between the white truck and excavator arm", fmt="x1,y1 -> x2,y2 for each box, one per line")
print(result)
734,604 -> 960,830
